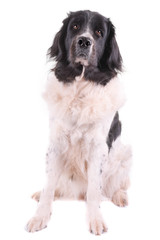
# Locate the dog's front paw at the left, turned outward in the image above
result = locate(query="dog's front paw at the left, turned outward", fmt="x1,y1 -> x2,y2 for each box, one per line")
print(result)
26,215 -> 50,232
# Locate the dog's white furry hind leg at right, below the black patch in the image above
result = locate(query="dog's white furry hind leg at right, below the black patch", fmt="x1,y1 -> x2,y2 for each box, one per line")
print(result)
102,138 -> 132,207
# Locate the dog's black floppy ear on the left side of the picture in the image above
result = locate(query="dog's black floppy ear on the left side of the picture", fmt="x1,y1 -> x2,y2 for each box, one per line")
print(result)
48,17 -> 69,61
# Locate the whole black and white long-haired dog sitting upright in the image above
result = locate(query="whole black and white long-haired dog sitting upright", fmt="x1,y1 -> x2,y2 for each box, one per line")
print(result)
26,11 -> 131,235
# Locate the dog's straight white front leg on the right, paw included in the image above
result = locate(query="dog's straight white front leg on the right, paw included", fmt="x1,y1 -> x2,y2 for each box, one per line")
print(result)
87,143 -> 107,235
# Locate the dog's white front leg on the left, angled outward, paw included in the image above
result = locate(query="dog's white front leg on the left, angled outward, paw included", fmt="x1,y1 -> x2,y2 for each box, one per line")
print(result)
26,146 -> 62,232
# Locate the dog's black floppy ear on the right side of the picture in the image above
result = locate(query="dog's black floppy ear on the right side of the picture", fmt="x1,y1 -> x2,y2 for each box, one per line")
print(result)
100,19 -> 122,77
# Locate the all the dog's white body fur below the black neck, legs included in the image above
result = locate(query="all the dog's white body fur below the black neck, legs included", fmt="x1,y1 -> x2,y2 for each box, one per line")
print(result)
27,74 -> 130,234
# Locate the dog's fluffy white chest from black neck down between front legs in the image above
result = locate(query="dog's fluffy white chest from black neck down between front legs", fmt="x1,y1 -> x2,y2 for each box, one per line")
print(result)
44,71 -> 124,184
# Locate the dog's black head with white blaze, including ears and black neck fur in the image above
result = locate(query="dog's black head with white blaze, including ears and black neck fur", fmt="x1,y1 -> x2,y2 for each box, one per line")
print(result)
49,11 -> 122,85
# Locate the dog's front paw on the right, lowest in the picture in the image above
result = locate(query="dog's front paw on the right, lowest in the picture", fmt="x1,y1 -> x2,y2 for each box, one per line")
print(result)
89,218 -> 108,235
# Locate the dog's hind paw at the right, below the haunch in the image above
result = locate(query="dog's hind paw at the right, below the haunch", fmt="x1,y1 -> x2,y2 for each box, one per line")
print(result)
112,189 -> 128,207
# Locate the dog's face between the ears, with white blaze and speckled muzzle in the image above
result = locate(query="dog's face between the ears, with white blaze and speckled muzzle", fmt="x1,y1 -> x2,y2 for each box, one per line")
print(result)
65,12 -> 107,68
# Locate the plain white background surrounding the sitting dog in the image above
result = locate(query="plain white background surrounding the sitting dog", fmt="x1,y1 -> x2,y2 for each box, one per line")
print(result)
0,0 -> 160,240
